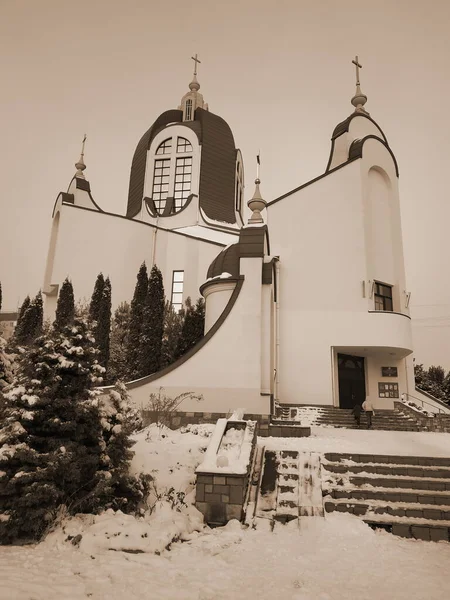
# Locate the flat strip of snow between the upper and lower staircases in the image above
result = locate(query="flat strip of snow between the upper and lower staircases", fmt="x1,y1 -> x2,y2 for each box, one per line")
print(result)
259,427 -> 450,457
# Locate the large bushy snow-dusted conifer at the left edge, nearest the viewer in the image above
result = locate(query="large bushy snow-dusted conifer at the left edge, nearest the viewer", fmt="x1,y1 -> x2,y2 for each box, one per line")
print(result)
0,320 -> 107,543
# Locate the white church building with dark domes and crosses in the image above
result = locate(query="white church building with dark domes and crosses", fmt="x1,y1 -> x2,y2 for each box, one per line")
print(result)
44,57 -> 415,414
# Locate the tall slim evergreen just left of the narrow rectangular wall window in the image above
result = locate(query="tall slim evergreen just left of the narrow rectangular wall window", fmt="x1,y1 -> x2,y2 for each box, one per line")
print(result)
138,265 -> 165,377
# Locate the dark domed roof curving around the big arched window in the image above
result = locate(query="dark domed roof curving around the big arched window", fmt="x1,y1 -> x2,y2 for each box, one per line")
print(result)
126,108 -> 236,224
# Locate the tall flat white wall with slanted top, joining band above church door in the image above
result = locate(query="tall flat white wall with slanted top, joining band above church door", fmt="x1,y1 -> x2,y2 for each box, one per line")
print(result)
269,148 -> 412,404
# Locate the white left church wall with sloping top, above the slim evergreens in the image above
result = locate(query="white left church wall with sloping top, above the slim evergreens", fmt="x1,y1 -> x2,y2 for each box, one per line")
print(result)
45,205 -> 222,318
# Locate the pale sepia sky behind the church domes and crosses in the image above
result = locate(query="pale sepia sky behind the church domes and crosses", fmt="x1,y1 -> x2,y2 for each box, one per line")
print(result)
0,0 -> 450,369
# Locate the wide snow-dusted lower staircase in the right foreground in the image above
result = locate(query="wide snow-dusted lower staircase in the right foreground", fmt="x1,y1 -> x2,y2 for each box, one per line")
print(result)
322,454 -> 450,541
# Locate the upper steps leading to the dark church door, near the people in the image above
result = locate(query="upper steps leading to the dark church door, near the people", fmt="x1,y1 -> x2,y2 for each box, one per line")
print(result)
276,404 -> 423,431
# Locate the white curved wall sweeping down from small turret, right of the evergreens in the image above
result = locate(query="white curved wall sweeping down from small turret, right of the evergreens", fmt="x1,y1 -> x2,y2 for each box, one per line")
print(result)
126,258 -> 270,414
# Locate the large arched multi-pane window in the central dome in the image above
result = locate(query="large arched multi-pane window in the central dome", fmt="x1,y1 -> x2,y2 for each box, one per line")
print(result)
152,136 -> 193,215
